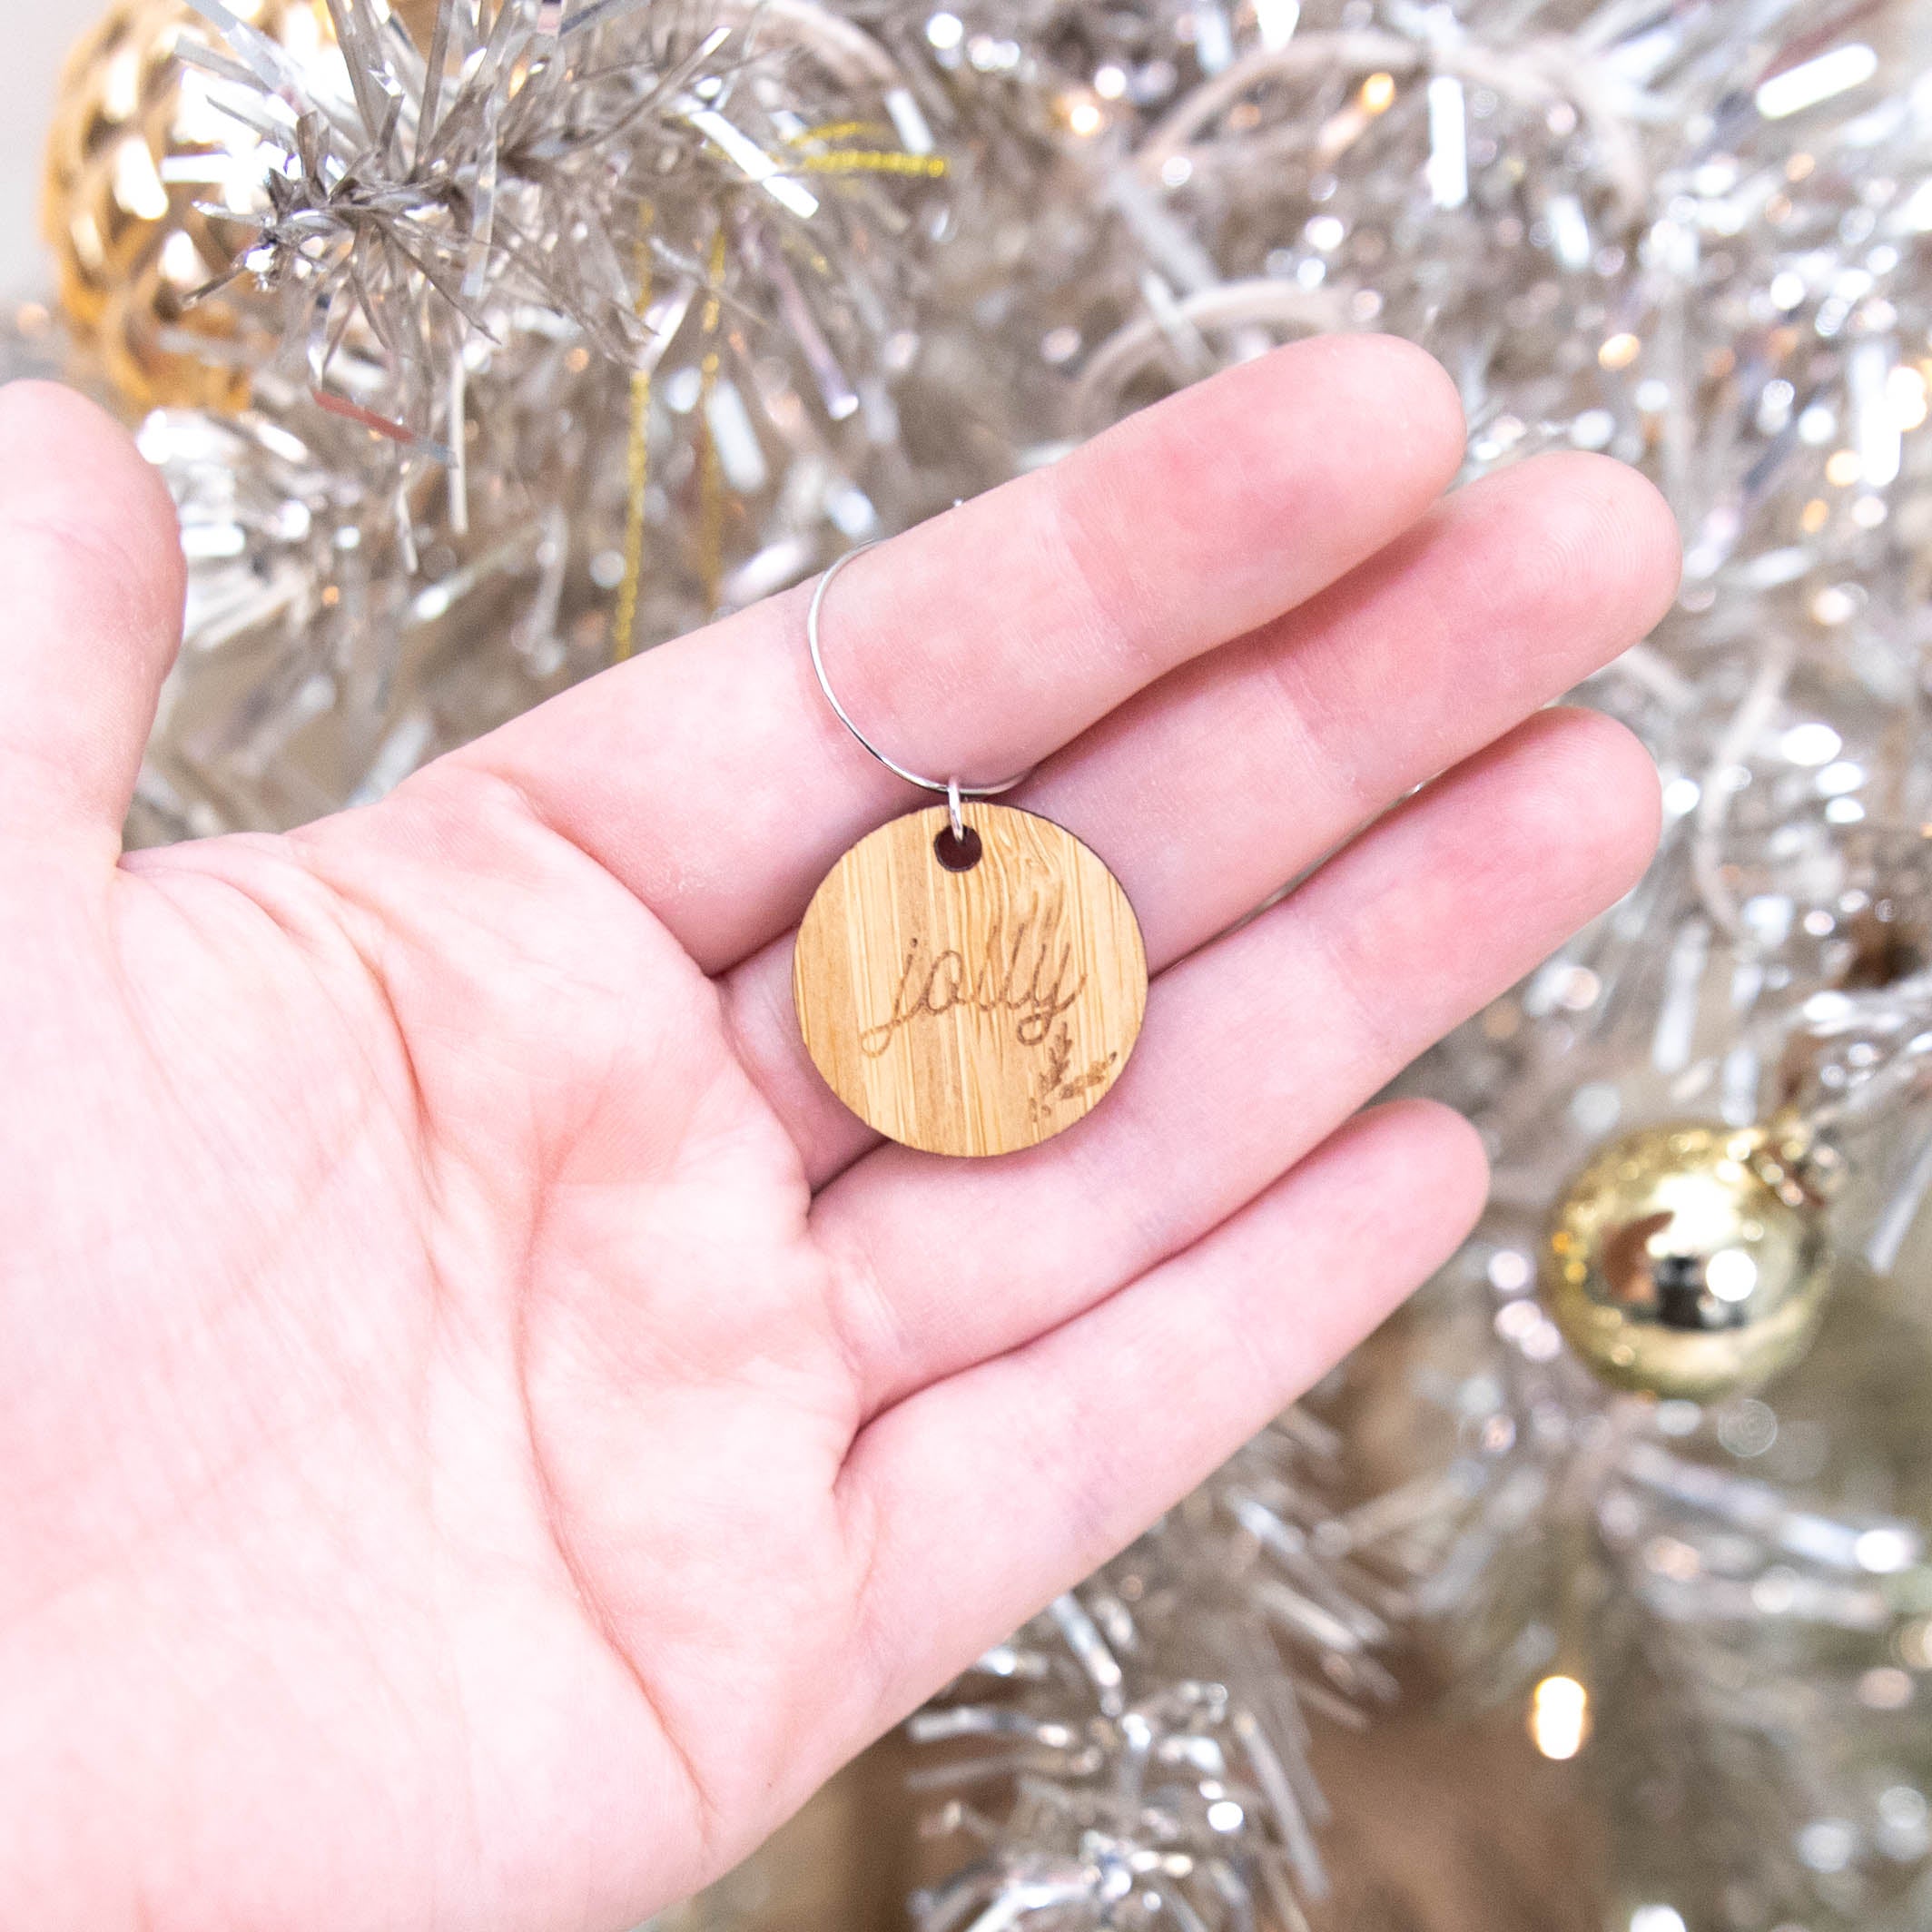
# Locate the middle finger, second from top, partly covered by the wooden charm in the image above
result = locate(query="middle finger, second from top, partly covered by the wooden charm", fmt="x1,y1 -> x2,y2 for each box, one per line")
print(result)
724,456 -> 1677,1187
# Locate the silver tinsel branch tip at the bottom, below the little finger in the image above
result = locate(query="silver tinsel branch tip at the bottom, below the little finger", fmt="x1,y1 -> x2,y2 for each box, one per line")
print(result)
912,1406 -> 1397,1932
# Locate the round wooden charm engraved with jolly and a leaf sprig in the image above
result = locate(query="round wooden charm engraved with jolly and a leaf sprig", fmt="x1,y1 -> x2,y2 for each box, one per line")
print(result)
792,803 -> 1148,1153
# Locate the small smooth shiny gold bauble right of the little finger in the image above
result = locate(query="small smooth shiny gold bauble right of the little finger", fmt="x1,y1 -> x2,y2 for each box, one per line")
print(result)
1542,1122 -> 1829,1401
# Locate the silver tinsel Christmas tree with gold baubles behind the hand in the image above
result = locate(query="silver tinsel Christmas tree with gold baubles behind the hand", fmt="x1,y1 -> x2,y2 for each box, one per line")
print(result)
23,0 -> 1932,1932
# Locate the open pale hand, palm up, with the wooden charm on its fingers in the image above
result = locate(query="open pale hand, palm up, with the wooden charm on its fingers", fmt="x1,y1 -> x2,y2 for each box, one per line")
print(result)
0,340 -> 1677,1932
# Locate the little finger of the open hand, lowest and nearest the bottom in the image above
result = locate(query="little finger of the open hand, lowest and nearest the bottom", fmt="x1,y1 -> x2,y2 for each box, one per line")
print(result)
841,1101 -> 1484,1725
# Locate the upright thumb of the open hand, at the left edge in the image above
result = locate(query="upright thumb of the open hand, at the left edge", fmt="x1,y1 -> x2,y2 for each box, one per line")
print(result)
0,382 -> 183,854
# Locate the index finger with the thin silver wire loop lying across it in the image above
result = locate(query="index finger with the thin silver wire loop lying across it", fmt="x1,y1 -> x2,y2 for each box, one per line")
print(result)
444,338 -> 1463,971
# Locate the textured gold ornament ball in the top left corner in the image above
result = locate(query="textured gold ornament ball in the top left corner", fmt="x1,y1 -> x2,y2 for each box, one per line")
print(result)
43,0 -> 334,409
